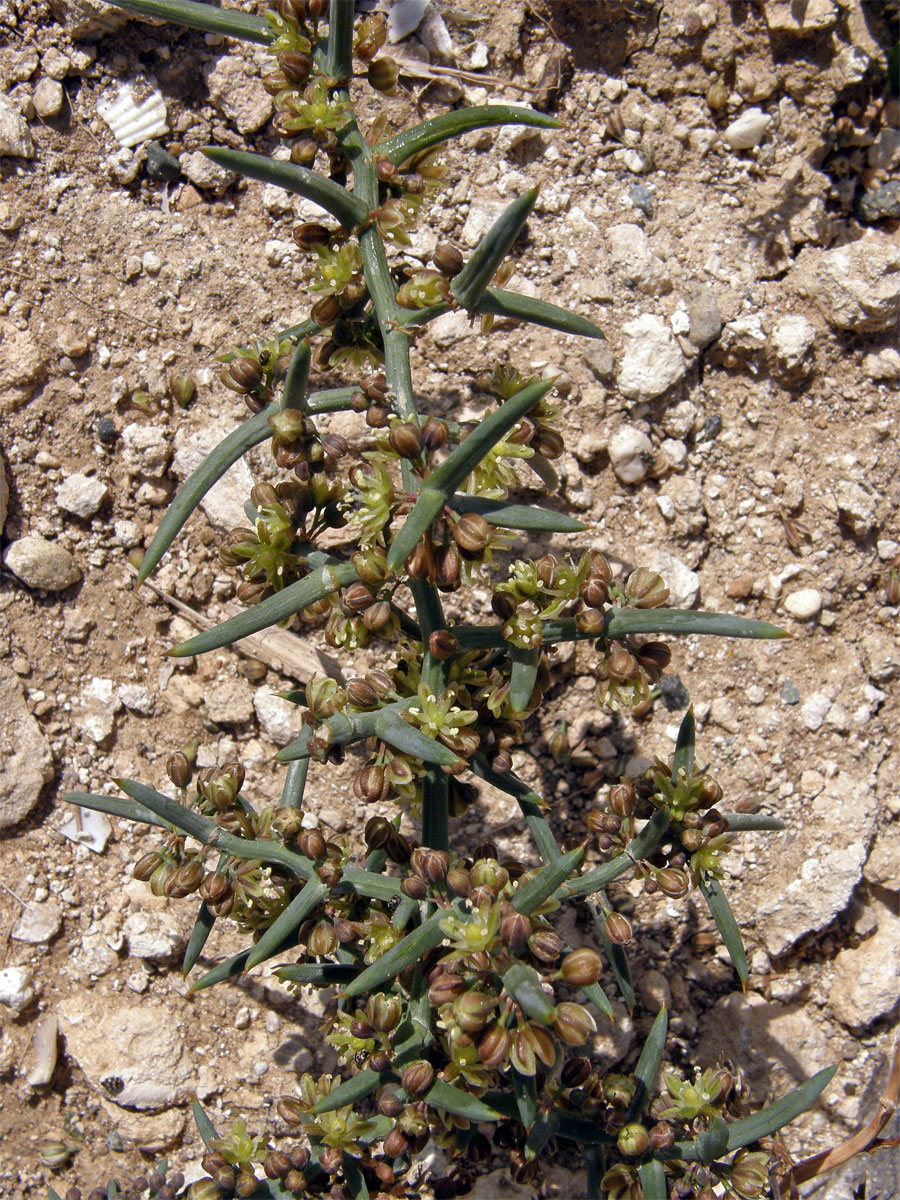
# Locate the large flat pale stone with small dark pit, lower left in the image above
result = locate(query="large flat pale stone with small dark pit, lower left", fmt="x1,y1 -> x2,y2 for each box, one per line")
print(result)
59,992 -> 193,1109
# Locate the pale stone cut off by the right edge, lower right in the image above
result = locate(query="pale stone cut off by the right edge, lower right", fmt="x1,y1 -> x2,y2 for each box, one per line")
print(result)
828,896 -> 900,1030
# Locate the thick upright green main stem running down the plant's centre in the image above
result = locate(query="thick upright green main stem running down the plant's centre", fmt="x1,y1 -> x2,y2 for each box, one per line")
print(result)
328,0 -> 450,850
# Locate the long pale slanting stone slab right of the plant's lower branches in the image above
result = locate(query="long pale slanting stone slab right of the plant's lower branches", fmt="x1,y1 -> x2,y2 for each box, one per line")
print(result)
737,773 -> 877,956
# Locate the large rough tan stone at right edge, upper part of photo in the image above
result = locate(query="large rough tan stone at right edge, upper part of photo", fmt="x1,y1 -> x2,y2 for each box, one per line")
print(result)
788,237 -> 900,334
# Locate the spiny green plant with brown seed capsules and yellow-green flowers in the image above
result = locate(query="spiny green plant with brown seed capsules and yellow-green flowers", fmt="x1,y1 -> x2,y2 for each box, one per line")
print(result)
60,0 -> 833,1200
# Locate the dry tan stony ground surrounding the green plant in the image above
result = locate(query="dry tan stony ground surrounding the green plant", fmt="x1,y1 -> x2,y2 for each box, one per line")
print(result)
0,0 -> 900,1200
